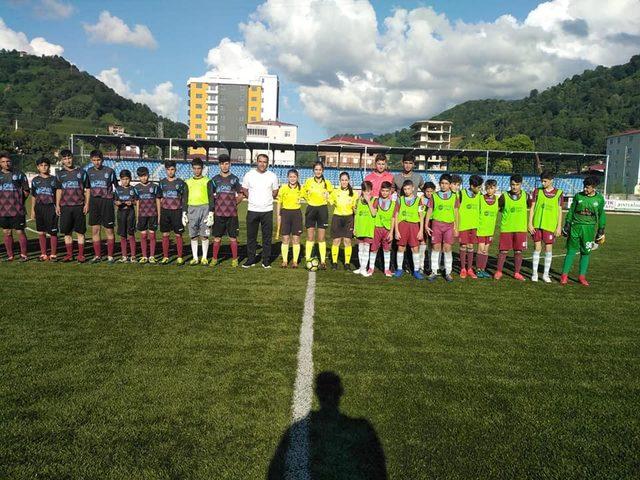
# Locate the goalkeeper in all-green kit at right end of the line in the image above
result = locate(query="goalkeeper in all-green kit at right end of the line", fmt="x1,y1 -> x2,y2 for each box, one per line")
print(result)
560,177 -> 606,287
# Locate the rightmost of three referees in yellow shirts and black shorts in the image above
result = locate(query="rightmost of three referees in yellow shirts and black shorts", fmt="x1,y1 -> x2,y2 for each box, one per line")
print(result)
329,172 -> 358,270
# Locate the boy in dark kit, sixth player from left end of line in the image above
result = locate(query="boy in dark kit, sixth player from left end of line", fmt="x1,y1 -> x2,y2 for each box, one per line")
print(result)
134,167 -> 160,263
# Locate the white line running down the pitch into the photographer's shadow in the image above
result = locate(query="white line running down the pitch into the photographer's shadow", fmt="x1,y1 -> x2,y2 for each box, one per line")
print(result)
285,272 -> 316,480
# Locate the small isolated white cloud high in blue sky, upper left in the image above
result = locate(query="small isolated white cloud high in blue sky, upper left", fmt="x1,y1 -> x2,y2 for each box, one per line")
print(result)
83,10 -> 158,48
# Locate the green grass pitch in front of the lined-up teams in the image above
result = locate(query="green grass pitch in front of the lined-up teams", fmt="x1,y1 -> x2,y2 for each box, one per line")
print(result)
0,211 -> 640,479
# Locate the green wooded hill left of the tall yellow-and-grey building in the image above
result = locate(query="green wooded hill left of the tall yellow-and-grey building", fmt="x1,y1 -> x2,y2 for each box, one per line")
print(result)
0,50 -> 187,154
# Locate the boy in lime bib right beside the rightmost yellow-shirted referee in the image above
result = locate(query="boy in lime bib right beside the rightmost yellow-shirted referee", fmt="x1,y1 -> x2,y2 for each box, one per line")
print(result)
354,180 -> 378,277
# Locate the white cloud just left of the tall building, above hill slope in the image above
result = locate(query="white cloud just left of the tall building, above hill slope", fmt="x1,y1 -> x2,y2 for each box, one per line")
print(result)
96,67 -> 180,120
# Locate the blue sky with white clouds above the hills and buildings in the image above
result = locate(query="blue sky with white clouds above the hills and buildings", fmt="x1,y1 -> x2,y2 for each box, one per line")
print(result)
0,0 -> 640,142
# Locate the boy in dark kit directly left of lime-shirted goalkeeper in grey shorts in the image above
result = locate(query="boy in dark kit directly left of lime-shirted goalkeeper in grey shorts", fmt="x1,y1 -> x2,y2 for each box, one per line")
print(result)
158,160 -> 187,266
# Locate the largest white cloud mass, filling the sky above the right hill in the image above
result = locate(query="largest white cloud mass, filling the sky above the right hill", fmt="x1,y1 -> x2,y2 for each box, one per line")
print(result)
202,0 -> 640,131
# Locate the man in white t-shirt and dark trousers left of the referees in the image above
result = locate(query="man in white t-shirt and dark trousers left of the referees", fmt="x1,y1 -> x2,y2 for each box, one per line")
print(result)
242,153 -> 278,268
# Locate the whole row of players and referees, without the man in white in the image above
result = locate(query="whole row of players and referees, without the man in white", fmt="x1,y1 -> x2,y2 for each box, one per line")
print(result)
0,150 -> 605,284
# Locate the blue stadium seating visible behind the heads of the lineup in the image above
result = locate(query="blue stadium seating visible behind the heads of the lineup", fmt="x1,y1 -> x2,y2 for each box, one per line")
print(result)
92,158 -> 583,196
